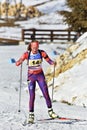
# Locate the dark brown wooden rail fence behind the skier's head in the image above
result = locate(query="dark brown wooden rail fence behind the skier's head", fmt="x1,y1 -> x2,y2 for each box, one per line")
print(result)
22,29 -> 75,42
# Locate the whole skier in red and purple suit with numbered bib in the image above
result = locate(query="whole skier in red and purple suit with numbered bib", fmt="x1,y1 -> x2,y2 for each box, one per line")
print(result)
16,41 -> 57,123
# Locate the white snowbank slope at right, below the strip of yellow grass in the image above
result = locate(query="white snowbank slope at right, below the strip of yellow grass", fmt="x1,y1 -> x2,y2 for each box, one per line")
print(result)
55,59 -> 87,106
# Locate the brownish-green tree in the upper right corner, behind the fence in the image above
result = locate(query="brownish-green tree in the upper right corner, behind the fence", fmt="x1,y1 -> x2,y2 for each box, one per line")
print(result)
60,0 -> 87,32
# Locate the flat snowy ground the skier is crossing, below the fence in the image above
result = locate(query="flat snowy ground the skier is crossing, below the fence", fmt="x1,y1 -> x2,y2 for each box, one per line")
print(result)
0,44 -> 87,130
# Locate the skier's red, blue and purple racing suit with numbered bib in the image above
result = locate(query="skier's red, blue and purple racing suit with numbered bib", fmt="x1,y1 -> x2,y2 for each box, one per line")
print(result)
16,50 -> 54,112
